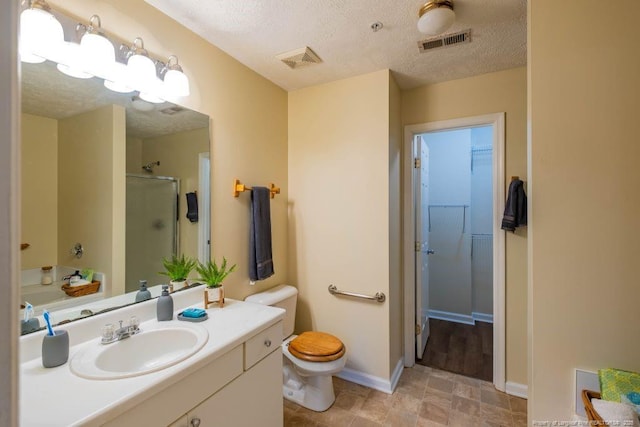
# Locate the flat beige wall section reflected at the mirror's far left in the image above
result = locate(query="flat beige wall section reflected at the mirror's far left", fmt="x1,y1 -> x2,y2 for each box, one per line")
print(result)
20,114 -> 58,270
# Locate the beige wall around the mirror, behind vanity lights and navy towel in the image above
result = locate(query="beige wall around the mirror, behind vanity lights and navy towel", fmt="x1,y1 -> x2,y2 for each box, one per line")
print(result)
49,0 -> 288,298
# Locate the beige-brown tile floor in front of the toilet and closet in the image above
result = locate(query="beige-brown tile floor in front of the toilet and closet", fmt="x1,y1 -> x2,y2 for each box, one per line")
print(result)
284,365 -> 527,427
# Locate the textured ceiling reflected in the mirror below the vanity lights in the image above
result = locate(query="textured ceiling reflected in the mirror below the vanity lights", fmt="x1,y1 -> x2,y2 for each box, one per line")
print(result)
21,61 -> 209,138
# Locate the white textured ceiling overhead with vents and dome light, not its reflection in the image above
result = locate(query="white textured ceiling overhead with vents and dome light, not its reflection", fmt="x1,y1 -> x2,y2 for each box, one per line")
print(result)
145,0 -> 527,90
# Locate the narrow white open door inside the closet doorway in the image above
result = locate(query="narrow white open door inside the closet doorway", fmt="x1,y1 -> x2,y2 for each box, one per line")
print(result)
414,135 -> 433,359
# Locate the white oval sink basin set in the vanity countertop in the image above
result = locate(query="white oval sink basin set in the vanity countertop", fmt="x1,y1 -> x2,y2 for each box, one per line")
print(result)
69,320 -> 209,380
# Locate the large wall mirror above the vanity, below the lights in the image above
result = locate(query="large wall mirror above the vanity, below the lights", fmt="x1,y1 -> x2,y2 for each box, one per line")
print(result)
20,61 -> 210,334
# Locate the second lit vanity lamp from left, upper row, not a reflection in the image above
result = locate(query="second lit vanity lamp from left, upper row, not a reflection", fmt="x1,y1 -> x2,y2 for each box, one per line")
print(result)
77,15 -> 116,79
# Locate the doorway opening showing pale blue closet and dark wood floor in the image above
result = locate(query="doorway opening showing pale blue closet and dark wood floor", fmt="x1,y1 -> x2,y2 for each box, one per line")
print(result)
414,126 -> 493,381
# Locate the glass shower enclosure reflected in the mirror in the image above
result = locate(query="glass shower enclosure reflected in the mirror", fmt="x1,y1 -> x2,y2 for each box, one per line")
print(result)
125,174 -> 180,292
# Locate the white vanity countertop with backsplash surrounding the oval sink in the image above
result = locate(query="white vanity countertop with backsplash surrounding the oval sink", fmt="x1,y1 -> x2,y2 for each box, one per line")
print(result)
20,288 -> 284,426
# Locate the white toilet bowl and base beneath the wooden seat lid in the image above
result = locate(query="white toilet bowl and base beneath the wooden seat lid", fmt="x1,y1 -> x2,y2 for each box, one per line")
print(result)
282,365 -> 336,412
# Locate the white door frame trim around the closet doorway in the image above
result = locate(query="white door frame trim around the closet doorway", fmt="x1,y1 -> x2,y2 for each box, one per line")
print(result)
402,112 -> 506,391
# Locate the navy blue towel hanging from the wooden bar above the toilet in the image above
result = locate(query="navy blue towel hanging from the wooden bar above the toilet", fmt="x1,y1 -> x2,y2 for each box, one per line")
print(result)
249,187 -> 273,281
